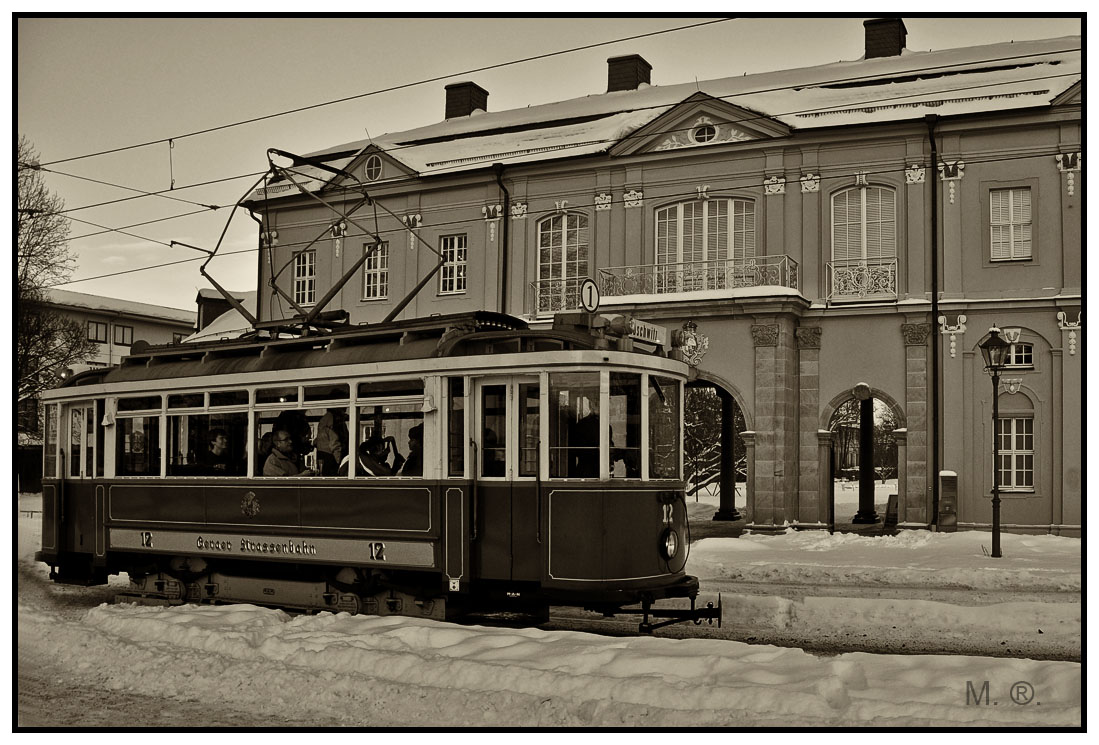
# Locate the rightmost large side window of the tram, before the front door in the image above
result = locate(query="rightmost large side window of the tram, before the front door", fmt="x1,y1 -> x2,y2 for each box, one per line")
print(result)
355,402 -> 423,477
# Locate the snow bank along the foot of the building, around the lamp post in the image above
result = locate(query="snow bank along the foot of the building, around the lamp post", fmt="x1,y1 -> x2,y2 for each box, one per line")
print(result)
687,529 -> 1080,592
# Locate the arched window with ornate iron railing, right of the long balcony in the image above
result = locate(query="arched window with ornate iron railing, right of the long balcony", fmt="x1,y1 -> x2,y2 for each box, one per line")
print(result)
829,186 -> 897,300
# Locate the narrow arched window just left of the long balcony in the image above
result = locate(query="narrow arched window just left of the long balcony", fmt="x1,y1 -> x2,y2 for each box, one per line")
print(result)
536,212 -> 588,313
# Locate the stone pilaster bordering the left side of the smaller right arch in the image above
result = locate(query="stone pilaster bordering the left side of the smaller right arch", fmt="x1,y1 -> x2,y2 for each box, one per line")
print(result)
795,326 -> 831,527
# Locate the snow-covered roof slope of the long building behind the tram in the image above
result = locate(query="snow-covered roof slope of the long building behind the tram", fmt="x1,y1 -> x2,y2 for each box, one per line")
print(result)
286,36 -> 1081,189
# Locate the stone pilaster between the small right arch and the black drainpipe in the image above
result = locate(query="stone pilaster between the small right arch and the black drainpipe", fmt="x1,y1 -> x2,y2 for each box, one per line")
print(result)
898,323 -> 931,525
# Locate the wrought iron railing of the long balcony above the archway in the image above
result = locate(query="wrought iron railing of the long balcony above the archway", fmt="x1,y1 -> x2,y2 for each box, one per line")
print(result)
599,256 -> 798,297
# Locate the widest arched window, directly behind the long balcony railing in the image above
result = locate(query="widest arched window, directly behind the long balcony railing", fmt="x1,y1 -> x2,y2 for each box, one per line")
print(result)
656,199 -> 755,292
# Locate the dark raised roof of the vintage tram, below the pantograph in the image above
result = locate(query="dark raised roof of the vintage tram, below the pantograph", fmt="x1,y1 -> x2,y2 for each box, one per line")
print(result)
62,311 -> 659,388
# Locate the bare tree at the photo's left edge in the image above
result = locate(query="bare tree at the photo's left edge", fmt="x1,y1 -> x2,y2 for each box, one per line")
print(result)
15,136 -> 95,415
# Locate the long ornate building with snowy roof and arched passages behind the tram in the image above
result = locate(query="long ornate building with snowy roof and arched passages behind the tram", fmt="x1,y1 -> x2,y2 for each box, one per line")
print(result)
242,19 -> 1083,534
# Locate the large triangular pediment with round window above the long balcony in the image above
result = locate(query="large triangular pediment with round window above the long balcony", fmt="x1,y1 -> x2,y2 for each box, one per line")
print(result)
610,92 -> 790,156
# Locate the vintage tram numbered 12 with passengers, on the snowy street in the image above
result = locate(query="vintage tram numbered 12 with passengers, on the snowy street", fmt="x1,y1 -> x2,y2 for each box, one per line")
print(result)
36,312 -> 720,629
